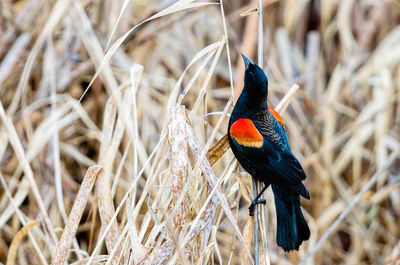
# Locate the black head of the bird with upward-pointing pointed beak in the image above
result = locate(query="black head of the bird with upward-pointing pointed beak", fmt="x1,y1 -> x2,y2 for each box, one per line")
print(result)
242,53 -> 268,99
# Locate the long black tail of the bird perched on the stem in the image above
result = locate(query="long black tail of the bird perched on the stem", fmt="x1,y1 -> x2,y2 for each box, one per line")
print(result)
272,185 -> 310,251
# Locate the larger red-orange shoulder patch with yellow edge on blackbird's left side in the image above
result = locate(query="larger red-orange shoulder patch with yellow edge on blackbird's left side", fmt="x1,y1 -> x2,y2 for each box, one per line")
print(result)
229,118 -> 263,147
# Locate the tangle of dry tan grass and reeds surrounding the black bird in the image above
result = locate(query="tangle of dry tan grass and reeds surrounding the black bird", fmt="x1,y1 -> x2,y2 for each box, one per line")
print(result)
0,0 -> 400,265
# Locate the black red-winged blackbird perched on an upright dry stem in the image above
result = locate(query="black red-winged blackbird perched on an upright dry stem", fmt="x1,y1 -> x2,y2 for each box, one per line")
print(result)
227,53 -> 310,252
